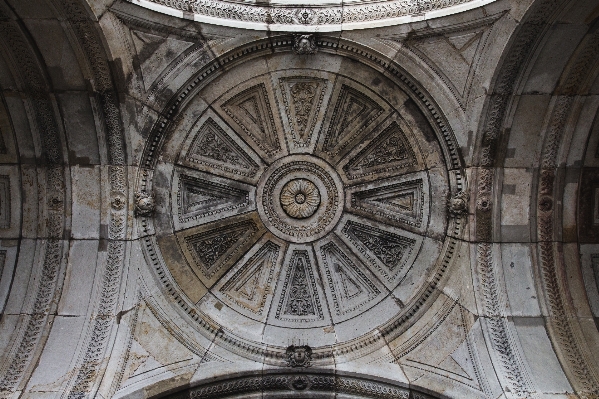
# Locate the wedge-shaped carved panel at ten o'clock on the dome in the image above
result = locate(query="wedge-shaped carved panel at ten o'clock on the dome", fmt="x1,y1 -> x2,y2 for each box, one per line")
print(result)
186,118 -> 258,177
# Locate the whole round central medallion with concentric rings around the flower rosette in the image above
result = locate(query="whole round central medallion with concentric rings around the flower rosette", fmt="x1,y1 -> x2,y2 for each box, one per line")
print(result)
257,155 -> 344,243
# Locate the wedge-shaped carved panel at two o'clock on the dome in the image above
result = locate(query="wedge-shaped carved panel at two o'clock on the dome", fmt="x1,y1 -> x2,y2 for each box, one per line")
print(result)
343,122 -> 417,180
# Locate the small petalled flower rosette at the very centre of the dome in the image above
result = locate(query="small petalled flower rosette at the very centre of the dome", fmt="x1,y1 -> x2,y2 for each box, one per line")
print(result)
280,179 -> 320,219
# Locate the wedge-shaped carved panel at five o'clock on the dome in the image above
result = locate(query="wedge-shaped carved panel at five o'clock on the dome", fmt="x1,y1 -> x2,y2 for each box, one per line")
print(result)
320,242 -> 381,316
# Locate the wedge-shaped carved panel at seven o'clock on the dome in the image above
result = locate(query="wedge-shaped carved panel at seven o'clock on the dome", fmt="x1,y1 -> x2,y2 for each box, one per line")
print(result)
220,241 -> 280,316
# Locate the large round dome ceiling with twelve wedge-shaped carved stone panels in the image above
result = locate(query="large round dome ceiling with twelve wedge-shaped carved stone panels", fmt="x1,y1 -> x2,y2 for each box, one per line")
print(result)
142,52 -> 466,362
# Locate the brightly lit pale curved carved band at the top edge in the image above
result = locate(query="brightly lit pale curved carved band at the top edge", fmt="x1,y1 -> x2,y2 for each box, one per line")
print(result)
130,0 -> 496,32
